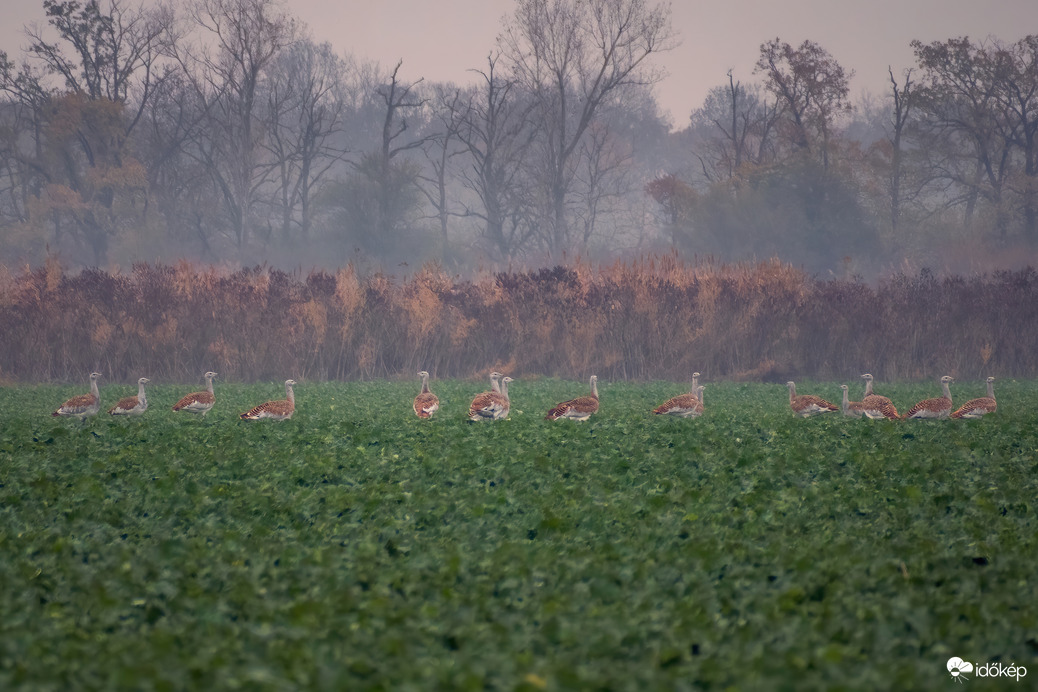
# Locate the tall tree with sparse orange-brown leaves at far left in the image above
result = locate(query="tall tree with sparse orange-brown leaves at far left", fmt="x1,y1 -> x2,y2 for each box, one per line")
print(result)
0,0 -> 161,265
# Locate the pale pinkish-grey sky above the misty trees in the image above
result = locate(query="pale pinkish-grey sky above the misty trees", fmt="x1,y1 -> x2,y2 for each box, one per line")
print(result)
6,0 -> 1038,128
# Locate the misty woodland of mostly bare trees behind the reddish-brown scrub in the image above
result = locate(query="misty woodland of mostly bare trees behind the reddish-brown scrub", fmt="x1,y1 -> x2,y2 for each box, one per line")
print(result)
0,0 -> 1038,278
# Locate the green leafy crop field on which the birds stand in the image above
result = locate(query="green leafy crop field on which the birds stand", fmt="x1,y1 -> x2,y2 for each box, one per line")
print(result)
0,378 -> 1038,691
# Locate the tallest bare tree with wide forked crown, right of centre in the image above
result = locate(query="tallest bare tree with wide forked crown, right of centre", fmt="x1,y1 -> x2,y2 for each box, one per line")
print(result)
500,0 -> 675,256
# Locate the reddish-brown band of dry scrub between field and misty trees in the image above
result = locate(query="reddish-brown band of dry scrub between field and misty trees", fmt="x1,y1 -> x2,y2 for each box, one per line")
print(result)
0,255 -> 1038,382
